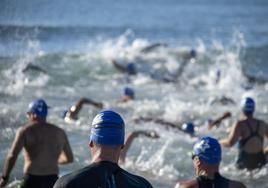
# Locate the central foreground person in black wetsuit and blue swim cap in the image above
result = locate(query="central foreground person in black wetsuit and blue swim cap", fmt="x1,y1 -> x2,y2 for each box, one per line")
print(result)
54,110 -> 152,188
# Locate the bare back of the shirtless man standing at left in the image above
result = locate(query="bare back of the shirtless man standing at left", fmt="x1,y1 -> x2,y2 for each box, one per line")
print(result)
15,123 -> 70,175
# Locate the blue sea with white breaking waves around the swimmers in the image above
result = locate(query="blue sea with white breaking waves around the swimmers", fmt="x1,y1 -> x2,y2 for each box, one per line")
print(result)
0,0 -> 268,188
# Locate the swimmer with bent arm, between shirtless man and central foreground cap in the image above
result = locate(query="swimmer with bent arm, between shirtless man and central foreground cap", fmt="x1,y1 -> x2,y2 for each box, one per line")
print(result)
61,98 -> 103,122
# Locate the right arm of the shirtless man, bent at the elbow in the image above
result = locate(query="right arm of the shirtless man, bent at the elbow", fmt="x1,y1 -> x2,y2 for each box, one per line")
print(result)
58,133 -> 73,164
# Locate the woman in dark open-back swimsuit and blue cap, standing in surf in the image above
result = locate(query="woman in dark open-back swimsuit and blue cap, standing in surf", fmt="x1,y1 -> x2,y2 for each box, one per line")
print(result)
220,97 -> 268,170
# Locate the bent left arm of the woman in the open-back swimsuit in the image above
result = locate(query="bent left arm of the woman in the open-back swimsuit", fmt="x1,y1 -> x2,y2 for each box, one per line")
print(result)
219,123 -> 241,147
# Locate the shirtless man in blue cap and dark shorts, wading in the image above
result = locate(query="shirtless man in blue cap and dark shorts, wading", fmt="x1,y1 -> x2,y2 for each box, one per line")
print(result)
0,99 -> 73,188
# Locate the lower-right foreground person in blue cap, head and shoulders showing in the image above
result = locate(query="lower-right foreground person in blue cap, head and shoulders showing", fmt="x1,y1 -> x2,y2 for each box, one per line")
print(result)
175,137 -> 246,188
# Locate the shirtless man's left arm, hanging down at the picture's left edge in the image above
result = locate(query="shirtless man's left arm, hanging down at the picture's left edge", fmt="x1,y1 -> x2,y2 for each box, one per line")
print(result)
0,127 -> 25,188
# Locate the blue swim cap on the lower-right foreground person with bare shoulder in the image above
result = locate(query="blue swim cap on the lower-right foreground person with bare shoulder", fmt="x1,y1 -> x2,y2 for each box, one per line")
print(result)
192,137 -> 221,164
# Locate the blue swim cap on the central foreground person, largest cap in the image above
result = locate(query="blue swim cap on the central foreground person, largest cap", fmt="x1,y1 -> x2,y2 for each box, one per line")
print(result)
90,110 -> 125,145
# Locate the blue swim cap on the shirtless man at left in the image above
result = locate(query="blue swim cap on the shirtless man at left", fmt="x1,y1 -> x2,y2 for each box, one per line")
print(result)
27,99 -> 48,117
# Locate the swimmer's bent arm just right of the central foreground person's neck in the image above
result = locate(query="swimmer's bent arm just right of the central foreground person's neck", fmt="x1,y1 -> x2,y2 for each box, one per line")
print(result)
120,130 -> 159,162
